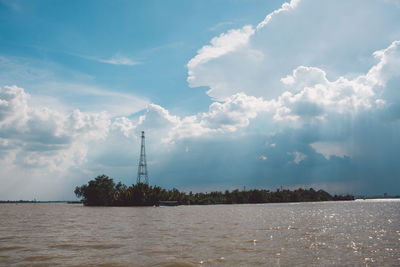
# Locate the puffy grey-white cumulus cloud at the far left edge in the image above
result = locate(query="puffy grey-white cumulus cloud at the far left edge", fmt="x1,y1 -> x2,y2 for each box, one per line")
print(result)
0,86 -> 110,170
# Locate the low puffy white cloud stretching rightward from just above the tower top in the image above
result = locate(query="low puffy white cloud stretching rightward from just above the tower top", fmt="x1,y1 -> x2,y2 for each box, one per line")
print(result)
125,94 -> 275,143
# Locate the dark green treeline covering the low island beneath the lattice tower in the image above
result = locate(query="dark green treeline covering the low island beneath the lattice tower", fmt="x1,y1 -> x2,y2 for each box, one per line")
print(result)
75,175 -> 354,206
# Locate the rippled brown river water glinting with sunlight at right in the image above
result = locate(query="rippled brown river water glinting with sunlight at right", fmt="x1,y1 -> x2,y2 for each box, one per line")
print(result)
0,200 -> 400,266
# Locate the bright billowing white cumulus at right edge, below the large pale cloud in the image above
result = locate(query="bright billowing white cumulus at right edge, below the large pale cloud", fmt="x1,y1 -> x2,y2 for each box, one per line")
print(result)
275,41 -> 400,120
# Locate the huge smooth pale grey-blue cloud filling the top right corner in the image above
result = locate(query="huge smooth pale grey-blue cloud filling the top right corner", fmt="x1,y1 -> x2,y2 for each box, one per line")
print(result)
187,0 -> 400,100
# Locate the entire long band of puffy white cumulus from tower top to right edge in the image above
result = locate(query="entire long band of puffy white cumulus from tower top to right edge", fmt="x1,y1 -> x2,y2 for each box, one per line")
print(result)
114,38 -> 400,147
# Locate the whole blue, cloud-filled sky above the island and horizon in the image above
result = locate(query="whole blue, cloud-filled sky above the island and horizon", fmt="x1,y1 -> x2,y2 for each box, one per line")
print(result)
0,0 -> 400,200
